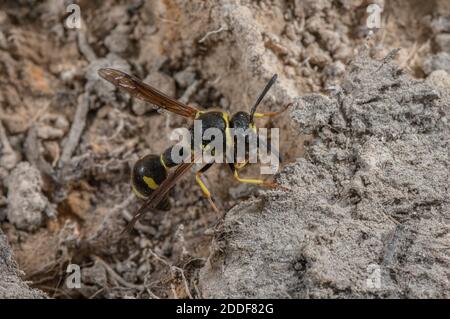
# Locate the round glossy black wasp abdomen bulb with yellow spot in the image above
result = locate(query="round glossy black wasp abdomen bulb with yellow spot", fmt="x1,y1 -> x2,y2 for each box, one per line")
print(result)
131,154 -> 167,198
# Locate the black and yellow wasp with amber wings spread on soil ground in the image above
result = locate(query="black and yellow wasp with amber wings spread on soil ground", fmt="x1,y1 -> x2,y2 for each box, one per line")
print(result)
98,68 -> 290,231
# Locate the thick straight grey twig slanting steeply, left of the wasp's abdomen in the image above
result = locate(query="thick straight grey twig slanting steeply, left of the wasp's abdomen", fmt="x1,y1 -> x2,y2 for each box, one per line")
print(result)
59,92 -> 89,168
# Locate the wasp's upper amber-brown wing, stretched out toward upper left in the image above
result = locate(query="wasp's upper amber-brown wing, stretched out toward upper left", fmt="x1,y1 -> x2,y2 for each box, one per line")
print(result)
98,68 -> 198,118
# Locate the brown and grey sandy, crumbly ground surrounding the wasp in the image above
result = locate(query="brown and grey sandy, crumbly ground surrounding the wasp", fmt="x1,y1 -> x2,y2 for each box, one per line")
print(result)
0,0 -> 450,298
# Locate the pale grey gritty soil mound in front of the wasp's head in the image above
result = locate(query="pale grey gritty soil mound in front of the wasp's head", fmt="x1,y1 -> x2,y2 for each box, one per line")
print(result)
201,53 -> 450,298
